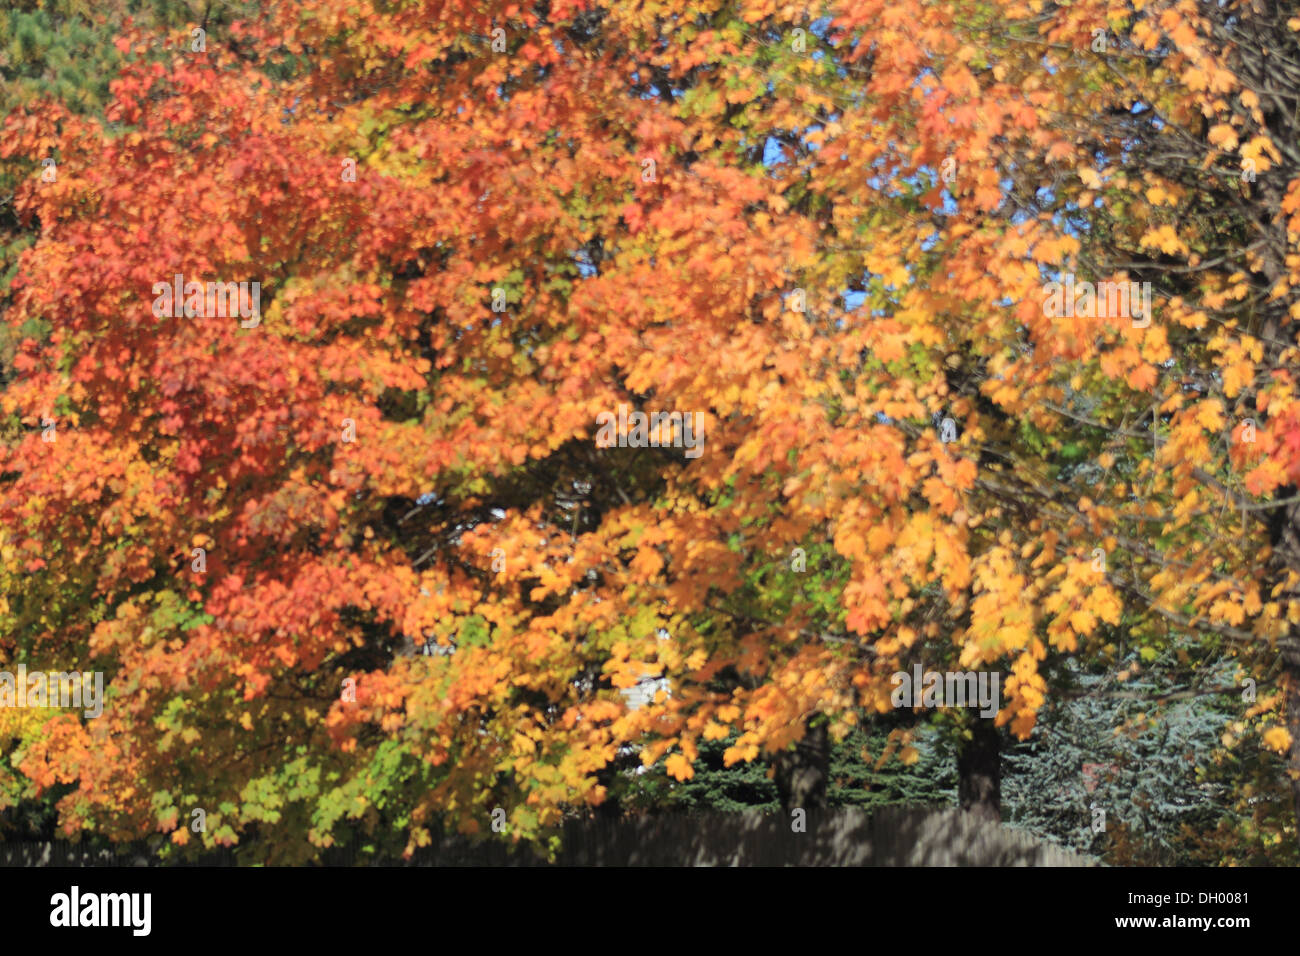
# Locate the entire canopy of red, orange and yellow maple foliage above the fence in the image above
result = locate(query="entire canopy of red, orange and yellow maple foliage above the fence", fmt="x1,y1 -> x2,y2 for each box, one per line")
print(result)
0,0 -> 1296,858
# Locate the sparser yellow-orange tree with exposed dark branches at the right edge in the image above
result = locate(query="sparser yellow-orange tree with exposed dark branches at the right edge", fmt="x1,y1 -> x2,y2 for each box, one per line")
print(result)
946,3 -> 1300,853
